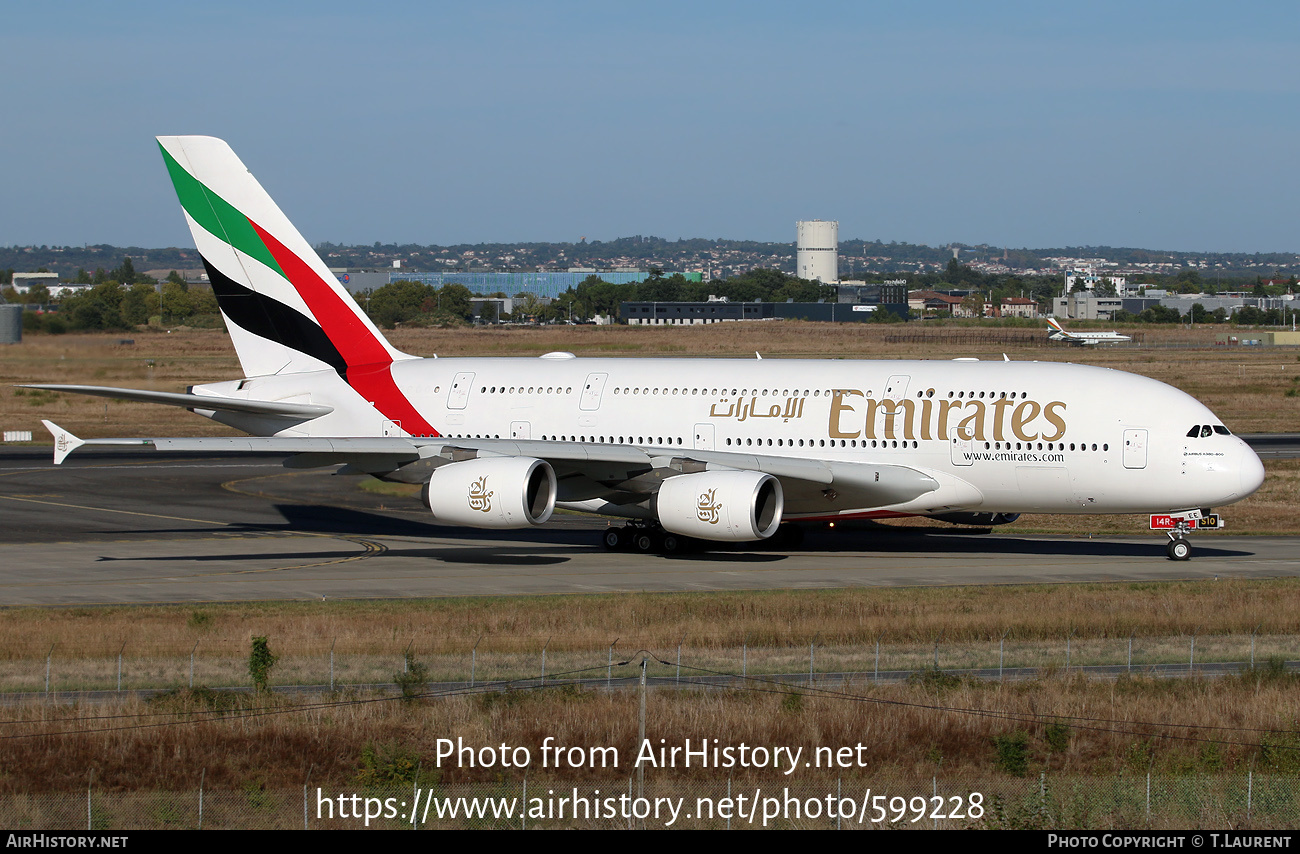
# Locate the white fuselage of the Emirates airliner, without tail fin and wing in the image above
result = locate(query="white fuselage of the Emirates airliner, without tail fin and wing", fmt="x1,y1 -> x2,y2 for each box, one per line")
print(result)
196,354 -> 1264,519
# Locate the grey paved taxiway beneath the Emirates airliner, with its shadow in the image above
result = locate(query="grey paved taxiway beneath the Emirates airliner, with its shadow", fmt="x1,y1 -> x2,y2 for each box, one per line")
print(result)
0,447 -> 1300,606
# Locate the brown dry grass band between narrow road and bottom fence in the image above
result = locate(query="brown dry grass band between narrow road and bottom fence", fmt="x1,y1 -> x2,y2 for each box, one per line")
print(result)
0,667 -> 1300,793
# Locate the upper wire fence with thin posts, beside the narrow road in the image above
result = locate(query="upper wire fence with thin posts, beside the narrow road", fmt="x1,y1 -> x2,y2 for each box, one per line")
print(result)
0,634 -> 1300,701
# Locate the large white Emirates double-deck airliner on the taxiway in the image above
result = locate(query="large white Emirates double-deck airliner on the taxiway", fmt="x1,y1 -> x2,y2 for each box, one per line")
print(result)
31,136 -> 1264,559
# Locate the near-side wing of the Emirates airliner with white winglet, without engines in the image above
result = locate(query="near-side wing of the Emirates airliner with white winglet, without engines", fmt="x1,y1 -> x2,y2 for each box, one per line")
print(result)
43,421 -> 939,515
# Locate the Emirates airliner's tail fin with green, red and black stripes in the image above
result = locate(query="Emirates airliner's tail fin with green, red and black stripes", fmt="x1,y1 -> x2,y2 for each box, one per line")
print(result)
157,136 -> 411,377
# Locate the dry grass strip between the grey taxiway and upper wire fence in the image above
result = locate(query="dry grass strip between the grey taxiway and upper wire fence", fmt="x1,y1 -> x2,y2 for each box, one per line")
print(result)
0,578 -> 1300,665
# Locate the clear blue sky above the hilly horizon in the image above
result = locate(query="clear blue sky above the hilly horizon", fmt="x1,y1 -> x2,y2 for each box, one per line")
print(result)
0,0 -> 1300,252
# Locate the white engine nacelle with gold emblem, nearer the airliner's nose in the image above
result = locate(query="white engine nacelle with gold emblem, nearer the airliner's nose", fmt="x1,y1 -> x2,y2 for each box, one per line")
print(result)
655,472 -> 785,541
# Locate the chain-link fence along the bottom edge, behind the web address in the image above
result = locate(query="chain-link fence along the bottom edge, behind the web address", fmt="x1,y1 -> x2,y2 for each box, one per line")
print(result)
0,772 -> 1300,831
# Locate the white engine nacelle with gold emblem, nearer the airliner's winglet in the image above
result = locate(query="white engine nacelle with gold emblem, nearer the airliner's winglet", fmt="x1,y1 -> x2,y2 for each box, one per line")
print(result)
420,456 -> 555,528
